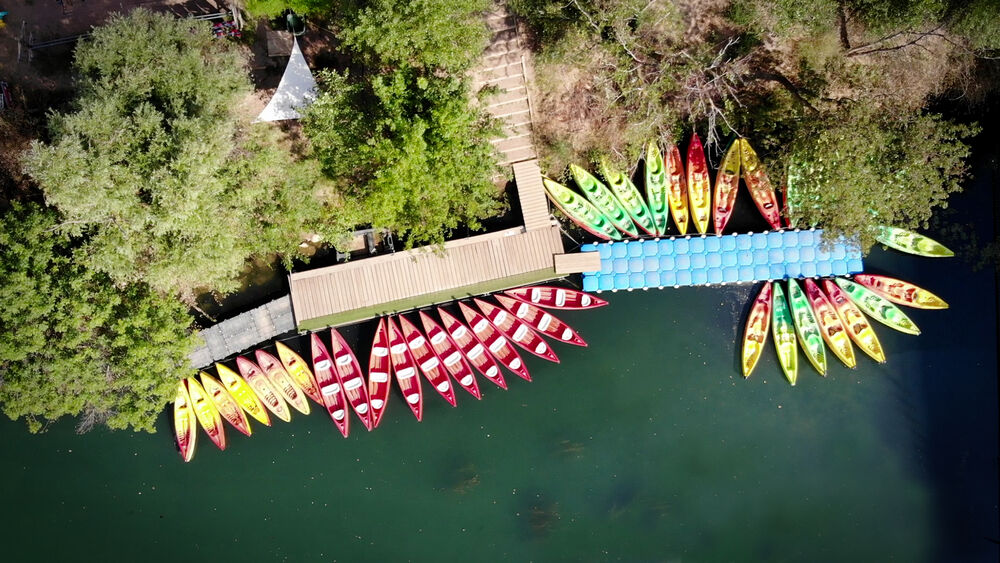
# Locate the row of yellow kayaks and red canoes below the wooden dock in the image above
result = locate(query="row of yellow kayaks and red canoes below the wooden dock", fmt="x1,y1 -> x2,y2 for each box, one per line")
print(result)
174,286 -> 607,461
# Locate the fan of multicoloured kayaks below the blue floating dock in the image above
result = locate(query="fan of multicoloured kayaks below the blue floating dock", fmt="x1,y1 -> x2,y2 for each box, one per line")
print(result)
741,274 -> 948,385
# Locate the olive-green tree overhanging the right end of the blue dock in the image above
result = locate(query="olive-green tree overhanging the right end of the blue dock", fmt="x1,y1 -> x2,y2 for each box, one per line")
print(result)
785,106 -> 977,251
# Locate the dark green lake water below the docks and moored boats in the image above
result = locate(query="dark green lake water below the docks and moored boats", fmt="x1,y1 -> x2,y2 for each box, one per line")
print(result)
0,182 -> 998,562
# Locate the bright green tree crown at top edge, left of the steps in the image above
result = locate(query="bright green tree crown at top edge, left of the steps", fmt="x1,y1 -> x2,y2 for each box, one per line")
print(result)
341,0 -> 489,74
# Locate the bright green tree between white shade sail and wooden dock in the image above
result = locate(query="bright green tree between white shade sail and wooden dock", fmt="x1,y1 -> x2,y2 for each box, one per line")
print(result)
303,68 -> 508,246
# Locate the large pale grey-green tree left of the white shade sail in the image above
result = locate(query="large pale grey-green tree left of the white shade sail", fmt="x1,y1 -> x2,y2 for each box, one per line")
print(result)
25,9 -> 340,295
